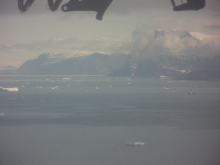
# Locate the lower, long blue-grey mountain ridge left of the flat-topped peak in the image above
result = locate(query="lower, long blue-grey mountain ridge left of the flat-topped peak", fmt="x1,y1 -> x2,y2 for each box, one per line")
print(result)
17,53 -> 127,75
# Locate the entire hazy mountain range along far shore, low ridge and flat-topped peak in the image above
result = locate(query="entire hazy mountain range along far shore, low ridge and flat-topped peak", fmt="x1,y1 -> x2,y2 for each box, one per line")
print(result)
9,29 -> 220,80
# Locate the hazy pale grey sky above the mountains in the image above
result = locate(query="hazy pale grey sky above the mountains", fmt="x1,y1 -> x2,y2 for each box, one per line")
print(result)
0,0 -> 220,66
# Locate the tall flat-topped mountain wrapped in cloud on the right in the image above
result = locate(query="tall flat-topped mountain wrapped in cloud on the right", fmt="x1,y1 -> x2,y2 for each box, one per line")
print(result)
110,29 -> 220,79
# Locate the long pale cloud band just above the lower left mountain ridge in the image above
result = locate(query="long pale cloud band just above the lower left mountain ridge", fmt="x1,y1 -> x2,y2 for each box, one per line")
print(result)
0,37 -> 132,54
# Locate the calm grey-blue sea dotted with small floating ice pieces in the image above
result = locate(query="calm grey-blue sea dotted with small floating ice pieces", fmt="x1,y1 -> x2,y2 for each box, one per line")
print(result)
0,76 -> 220,165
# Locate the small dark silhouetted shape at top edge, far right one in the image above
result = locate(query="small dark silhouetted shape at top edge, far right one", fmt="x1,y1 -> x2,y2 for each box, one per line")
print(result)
171,0 -> 205,11
